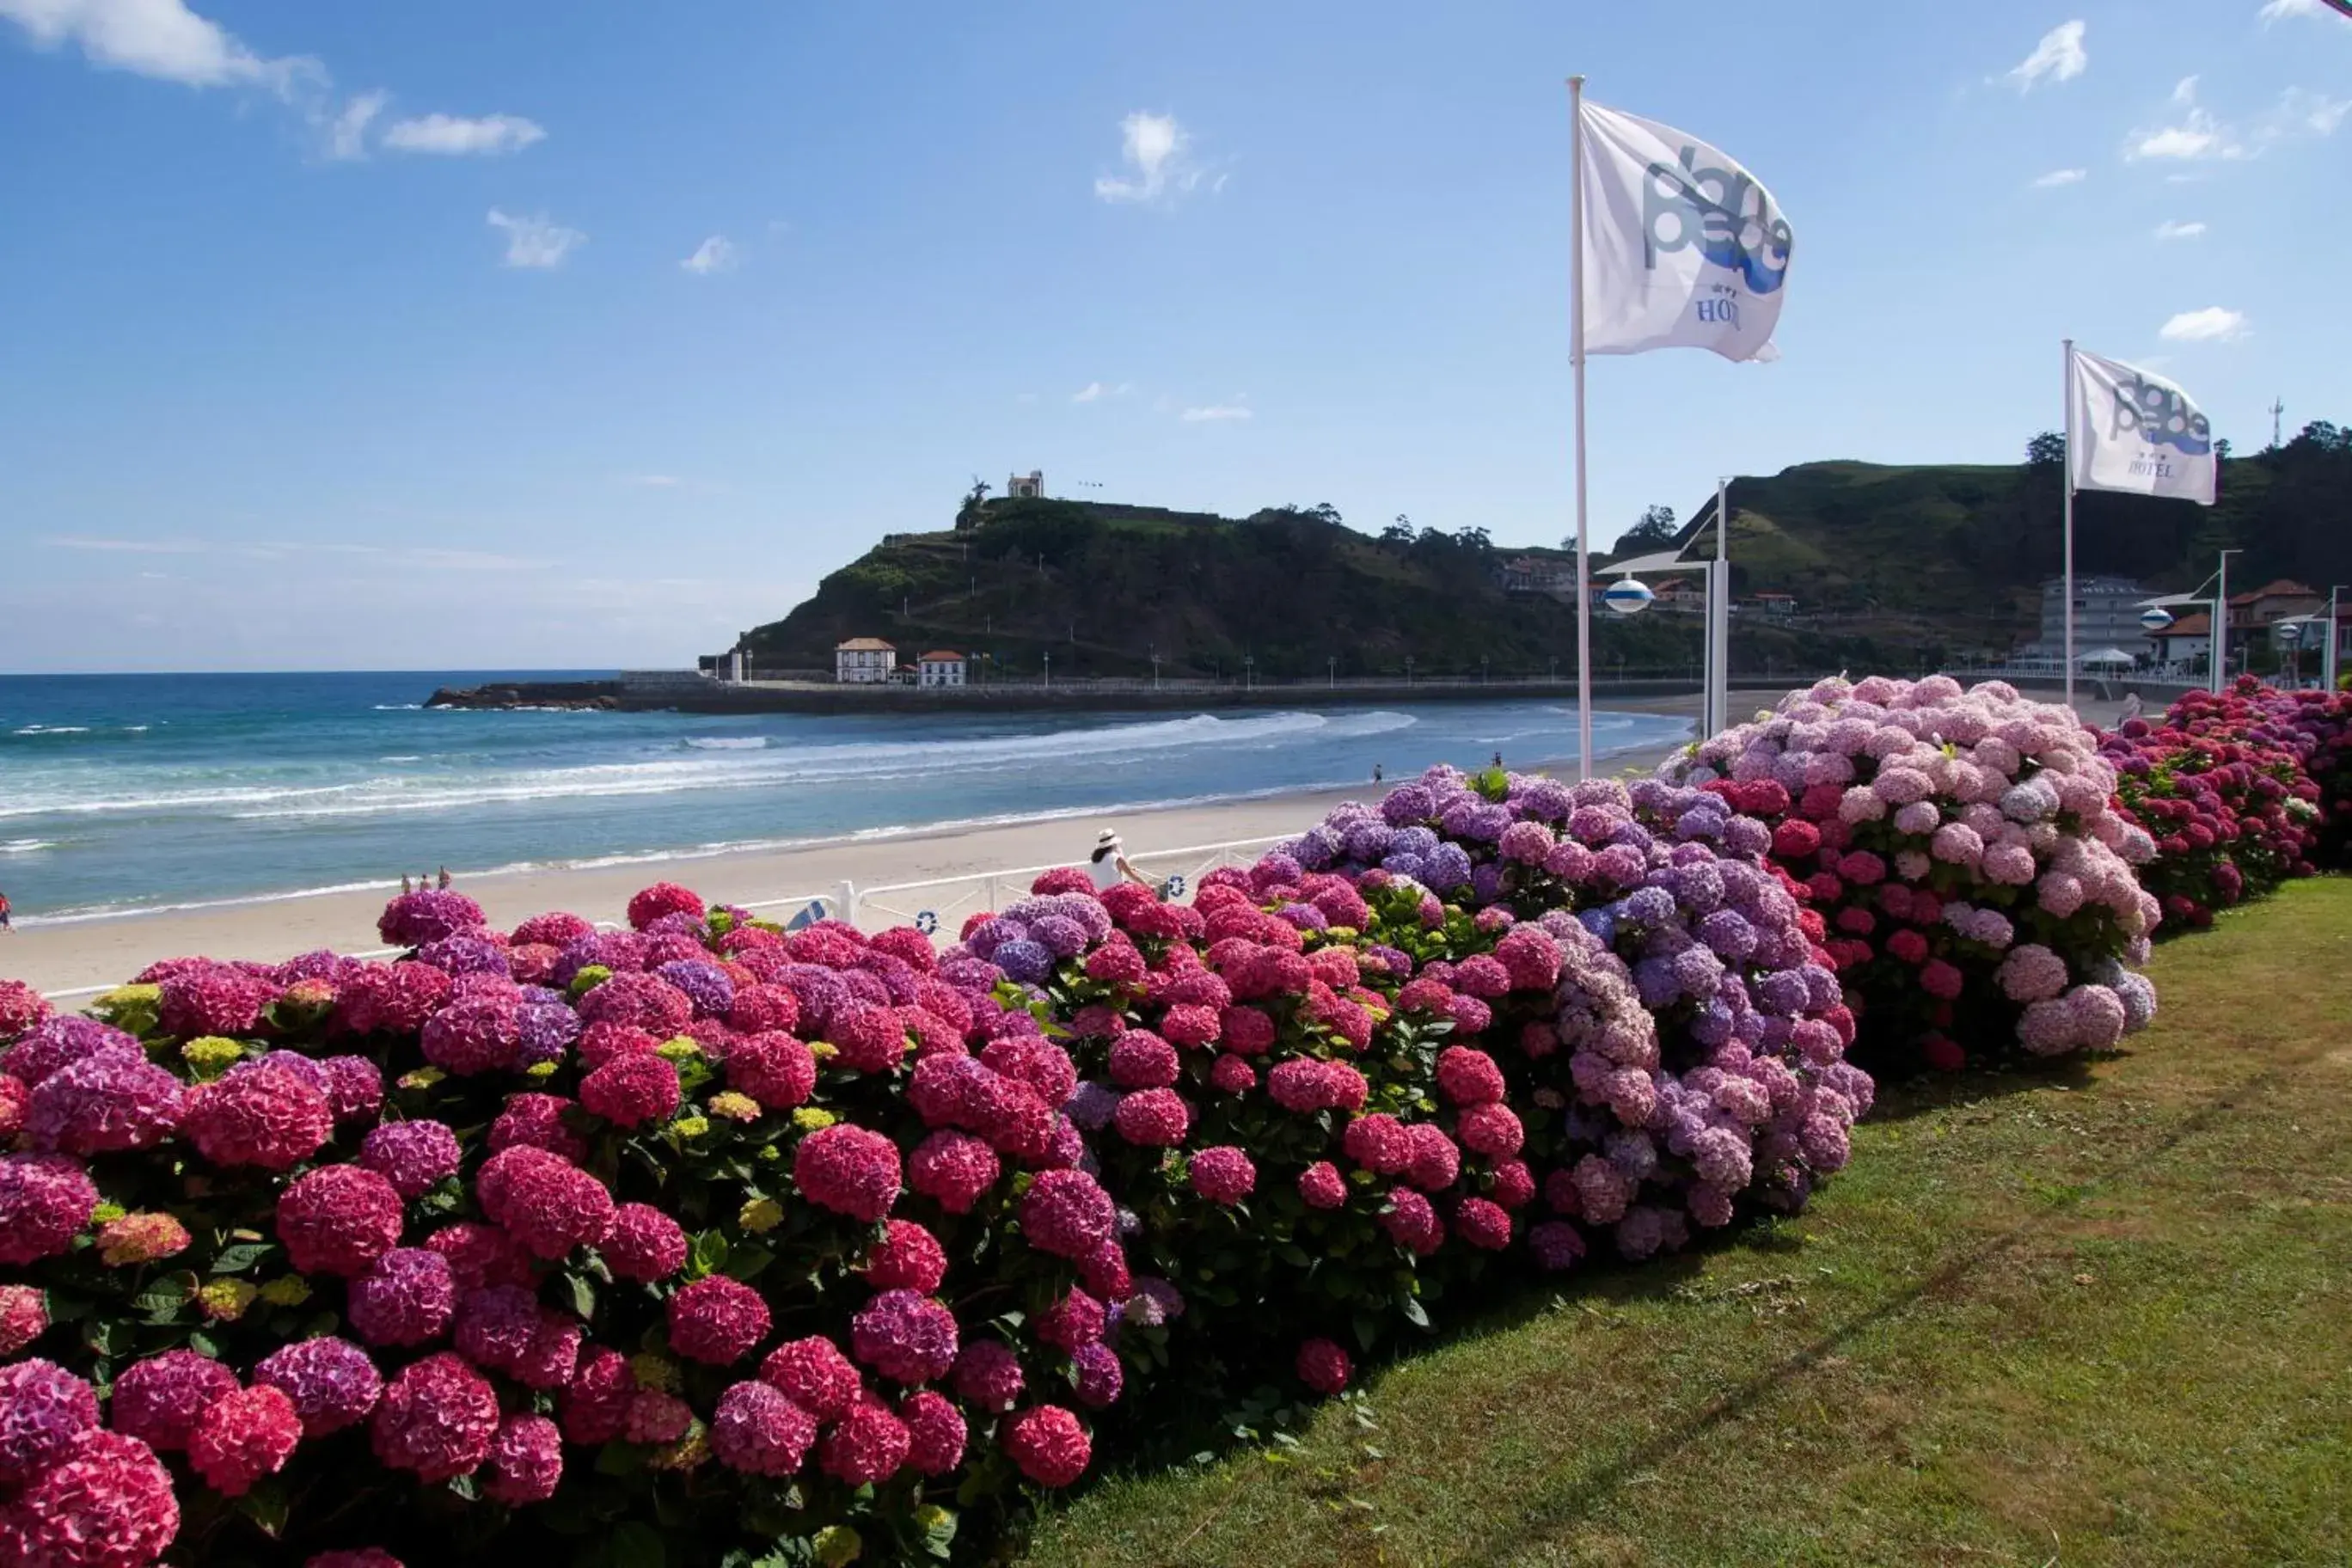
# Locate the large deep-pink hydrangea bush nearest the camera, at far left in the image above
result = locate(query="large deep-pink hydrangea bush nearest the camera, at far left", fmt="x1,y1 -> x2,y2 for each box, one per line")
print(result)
0,886 -> 1110,1564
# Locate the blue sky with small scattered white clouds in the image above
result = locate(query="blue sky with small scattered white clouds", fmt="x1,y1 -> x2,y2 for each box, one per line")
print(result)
0,0 -> 2352,670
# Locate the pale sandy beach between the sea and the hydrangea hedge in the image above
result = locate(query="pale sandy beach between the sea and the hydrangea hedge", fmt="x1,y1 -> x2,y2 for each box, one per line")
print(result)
0,691 -> 2115,992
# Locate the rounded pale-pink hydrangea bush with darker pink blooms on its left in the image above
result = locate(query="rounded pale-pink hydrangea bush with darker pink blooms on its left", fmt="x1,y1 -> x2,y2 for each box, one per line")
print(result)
1661,675 -> 2161,1068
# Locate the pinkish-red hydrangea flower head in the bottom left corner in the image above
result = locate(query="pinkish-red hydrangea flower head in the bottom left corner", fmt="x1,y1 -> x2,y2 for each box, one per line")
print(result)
0,1431 -> 179,1568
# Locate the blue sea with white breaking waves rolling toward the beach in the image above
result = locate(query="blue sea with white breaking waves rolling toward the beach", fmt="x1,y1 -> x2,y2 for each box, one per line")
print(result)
0,670 -> 1691,924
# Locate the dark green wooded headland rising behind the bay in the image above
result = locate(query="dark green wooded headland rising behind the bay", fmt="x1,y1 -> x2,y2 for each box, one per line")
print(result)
744,426 -> 2352,677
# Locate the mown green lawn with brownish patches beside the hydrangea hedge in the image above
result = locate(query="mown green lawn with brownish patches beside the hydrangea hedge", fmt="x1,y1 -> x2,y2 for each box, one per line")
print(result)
1020,877 -> 2352,1568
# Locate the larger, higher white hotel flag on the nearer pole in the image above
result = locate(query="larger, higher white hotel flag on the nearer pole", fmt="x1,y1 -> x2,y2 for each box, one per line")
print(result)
1581,103 -> 1790,359
